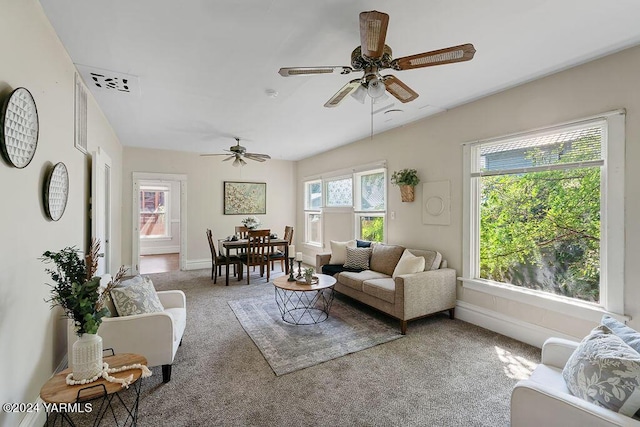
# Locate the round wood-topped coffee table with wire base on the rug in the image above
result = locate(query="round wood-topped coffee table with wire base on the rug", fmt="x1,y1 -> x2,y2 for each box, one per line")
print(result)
273,274 -> 336,325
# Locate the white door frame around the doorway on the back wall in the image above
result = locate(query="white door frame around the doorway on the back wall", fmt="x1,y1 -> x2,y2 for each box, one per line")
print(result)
131,172 -> 187,274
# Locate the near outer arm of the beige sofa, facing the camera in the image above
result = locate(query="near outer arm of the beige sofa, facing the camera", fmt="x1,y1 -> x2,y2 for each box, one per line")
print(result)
395,268 -> 456,319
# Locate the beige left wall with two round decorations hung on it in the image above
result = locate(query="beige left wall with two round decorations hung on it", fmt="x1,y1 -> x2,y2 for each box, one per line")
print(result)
0,0 -> 122,426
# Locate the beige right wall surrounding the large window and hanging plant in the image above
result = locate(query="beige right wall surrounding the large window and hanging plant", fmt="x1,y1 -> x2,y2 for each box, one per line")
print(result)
297,47 -> 640,337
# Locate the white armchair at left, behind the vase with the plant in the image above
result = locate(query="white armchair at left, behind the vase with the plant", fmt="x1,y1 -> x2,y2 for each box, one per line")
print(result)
67,277 -> 187,383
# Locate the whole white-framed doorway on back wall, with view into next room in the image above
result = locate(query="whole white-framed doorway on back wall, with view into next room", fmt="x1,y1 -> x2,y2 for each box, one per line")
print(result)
132,172 -> 186,274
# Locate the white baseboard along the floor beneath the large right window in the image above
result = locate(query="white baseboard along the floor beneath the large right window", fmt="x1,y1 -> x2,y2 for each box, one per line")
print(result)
456,300 -> 582,348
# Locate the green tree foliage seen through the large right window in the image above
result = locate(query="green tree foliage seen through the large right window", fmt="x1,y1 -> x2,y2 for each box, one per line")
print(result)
480,141 -> 600,302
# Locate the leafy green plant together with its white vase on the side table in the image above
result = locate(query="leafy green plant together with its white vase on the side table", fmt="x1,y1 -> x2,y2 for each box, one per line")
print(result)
40,240 -> 126,382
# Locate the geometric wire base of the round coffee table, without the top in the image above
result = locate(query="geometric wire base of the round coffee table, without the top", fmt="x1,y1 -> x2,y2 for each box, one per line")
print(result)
275,287 -> 334,325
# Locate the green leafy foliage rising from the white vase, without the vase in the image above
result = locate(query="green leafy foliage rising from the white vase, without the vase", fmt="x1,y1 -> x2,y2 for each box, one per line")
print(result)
40,240 -> 126,336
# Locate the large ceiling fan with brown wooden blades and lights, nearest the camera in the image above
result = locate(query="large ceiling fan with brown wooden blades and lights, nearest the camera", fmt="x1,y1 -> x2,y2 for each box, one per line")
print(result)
279,10 -> 476,108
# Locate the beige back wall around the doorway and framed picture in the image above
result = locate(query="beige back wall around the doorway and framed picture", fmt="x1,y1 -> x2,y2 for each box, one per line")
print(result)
122,147 -> 297,269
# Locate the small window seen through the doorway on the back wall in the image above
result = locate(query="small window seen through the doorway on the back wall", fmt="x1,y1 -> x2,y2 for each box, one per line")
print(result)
140,186 -> 171,239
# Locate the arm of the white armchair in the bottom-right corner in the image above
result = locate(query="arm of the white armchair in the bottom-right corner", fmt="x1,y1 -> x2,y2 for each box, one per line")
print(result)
511,380 -> 640,427
